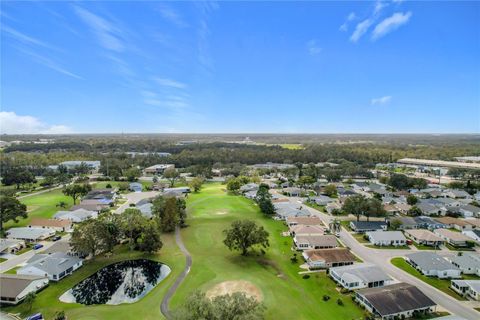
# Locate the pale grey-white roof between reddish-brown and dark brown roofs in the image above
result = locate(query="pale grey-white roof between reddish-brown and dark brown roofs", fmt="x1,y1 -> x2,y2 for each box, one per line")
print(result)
330,263 -> 392,283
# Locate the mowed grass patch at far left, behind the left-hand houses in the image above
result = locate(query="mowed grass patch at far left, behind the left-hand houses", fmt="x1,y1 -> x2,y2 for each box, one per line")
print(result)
4,189 -> 73,229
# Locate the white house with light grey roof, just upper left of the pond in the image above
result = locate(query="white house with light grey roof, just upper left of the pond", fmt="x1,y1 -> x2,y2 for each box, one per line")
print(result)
17,252 -> 83,281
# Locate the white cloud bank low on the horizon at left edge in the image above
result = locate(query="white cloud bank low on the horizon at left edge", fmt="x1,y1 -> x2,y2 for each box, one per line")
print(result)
0,111 -> 72,134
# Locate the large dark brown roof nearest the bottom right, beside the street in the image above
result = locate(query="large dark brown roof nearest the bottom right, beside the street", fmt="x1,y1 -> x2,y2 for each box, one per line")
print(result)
357,282 -> 436,316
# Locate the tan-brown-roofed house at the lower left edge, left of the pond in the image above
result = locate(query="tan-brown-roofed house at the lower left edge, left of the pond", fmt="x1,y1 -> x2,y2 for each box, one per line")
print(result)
0,273 -> 48,305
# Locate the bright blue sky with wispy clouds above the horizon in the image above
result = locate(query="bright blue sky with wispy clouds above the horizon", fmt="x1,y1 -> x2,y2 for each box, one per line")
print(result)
0,0 -> 480,133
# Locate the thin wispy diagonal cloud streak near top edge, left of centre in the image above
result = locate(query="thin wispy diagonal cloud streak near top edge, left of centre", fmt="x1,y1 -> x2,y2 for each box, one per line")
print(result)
74,6 -> 125,52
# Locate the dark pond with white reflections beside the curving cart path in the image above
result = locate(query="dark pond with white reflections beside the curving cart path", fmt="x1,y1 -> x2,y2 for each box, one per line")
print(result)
60,259 -> 171,305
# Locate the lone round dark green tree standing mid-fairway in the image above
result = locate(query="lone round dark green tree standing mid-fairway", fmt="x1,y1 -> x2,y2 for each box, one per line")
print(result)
223,220 -> 270,256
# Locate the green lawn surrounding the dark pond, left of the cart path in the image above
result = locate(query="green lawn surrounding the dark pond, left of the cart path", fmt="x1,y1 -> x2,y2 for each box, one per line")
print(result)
2,234 -> 185,320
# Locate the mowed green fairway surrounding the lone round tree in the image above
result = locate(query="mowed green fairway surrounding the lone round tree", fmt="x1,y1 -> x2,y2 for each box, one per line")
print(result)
170,184 -> 364,319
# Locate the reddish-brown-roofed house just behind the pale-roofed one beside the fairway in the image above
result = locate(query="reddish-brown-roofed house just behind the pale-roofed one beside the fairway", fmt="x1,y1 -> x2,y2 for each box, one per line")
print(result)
302,248 -> 355,269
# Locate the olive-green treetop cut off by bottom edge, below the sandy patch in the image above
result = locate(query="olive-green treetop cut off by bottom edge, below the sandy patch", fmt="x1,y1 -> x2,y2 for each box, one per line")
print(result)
173,291 -> 265,320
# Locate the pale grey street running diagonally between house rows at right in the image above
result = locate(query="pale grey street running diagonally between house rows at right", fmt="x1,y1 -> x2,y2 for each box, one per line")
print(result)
278,197 -> 480,320
